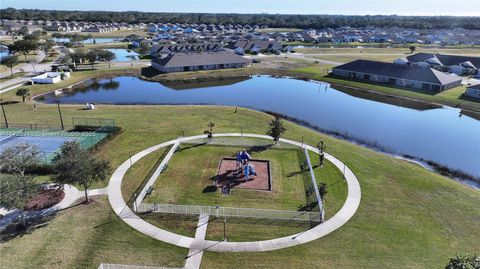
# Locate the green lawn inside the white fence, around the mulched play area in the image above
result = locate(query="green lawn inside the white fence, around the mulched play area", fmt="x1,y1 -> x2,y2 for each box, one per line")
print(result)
145,145 -> 312,210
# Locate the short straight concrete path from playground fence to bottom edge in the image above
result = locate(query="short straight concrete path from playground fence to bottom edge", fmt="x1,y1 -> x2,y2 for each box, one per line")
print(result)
185,214 -> 209,269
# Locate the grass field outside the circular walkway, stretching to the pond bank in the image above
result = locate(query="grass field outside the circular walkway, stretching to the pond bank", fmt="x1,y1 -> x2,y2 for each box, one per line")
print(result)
0,99 -> 480,268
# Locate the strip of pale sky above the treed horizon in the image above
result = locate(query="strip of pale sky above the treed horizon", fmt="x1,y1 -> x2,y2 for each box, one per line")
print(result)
0,0 -> 480,16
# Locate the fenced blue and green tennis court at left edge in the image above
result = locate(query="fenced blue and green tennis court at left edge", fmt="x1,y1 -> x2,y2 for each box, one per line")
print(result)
0,118 -> 116,164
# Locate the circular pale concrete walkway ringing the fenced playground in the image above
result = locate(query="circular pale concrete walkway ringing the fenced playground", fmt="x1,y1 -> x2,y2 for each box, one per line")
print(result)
108,133 -> 361,252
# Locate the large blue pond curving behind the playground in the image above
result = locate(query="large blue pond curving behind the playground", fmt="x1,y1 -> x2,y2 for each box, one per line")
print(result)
41,76 -> 480,176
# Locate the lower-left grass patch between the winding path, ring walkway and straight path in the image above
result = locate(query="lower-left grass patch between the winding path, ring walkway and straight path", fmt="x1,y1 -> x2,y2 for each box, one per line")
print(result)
0,197 -> 187,269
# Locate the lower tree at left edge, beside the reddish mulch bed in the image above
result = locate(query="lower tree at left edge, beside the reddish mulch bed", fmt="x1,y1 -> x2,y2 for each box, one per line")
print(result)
0,174 -> 38,227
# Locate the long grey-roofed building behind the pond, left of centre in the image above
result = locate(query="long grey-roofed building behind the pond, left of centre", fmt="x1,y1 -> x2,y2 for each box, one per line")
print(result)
152,51 -> 250,73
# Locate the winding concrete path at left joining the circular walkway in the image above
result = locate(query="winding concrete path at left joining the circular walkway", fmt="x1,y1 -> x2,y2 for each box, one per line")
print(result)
0,184 -> 107,232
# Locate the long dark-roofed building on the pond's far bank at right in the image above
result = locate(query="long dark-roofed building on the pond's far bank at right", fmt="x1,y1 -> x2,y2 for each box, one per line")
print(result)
332,60 -> 462,92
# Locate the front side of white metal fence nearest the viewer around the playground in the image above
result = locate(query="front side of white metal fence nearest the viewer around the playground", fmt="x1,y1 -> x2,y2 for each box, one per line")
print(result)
137,203 -> 321,222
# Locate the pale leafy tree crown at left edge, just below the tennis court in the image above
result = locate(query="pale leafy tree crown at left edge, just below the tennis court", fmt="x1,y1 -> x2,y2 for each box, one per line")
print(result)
0,143 -> 40,176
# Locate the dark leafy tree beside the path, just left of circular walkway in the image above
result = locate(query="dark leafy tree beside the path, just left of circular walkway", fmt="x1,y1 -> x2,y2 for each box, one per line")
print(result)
52,141 -> 110,202
